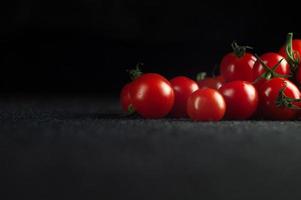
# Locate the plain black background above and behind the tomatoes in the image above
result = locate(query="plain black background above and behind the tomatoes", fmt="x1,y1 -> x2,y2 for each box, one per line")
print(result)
0,0 -> 301,93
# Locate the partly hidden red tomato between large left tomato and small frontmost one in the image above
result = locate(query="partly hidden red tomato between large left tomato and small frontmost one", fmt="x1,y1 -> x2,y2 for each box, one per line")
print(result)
170,76 -> 199,117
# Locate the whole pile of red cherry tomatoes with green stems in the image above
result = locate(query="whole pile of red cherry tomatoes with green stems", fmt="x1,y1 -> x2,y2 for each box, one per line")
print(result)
120,33 -> 301,121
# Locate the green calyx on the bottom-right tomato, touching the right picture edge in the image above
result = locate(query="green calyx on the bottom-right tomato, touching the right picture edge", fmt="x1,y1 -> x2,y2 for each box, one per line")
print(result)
276,82 -> 301,110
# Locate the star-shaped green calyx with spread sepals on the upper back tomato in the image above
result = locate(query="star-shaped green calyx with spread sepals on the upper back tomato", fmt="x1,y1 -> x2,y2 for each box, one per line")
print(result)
254,54 -> 290,83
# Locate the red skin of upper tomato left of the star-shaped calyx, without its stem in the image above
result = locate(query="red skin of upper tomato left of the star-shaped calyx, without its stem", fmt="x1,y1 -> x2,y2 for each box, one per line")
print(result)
220,53 -> 256,82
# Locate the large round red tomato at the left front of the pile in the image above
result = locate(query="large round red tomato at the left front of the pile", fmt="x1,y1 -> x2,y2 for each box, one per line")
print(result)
130,73 -> 174,118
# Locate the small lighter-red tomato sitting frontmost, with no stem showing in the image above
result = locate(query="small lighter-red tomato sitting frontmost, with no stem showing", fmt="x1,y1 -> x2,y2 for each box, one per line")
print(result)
187,88 -> 226,121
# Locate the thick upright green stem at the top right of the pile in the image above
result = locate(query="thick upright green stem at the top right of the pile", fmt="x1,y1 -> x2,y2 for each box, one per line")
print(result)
285,33 -> 300,72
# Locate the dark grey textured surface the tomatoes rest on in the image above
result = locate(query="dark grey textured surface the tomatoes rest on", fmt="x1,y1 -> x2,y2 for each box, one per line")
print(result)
0,96 -> 301,200
